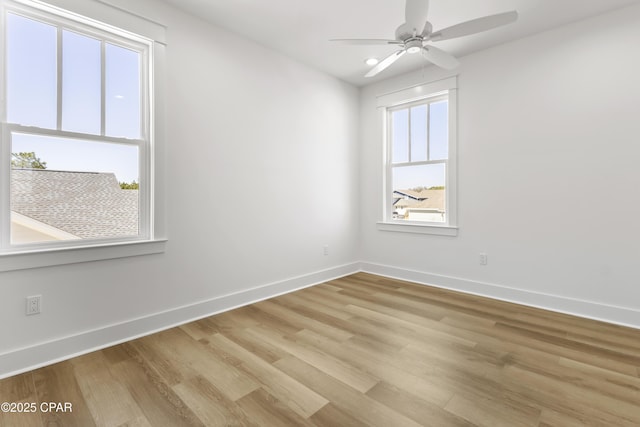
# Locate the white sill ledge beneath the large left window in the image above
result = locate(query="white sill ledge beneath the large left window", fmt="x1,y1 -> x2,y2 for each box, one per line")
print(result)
0,239 -> 167,272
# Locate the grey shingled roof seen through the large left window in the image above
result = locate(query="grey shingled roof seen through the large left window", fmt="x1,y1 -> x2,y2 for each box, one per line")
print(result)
11,169 -> 138,239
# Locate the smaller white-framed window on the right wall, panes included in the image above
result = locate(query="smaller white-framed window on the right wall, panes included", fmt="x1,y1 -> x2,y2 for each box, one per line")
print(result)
379,78 -> 456,234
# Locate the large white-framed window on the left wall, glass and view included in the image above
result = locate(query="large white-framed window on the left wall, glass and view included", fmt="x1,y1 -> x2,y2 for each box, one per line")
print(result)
0,0 -> 168,269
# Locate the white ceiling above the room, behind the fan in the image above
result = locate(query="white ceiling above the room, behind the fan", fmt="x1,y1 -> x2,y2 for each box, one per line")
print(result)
165,0 -> 640,86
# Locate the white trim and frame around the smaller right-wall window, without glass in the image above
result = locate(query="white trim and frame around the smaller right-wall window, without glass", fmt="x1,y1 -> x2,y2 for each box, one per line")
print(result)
377,76 -> 458,236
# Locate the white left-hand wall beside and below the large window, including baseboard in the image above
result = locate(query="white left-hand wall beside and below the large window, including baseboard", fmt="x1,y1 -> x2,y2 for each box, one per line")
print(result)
0,1 -> 359,377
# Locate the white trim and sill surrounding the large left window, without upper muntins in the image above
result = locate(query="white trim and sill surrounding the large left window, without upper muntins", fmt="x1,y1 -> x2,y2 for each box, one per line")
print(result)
0,0 -> 167,272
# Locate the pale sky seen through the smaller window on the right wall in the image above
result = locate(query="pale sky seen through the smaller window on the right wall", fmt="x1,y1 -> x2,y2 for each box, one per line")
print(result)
391,101 -> 449,190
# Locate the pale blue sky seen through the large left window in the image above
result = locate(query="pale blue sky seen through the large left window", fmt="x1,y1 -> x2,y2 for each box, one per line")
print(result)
7,14 -> 141,182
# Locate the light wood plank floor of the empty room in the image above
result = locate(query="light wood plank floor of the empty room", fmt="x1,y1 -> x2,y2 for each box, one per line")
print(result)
0,273 -> 640,427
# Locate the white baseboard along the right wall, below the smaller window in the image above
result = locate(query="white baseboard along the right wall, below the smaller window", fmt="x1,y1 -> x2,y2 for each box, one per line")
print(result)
361,262 -> 640,329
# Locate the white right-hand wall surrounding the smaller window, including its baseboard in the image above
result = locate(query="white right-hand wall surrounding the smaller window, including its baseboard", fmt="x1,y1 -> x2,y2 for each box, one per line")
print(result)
360,6 -> 640,327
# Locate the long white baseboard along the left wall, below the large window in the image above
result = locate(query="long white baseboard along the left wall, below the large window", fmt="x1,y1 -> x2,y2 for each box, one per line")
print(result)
0,262 -> 360,379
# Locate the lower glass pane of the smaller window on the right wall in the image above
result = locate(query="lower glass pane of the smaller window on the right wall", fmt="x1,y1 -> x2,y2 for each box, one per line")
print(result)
392,164 -> 446,222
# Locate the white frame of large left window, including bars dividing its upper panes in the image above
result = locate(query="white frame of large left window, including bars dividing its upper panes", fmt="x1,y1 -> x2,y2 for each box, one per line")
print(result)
0,0 -> 166,272
